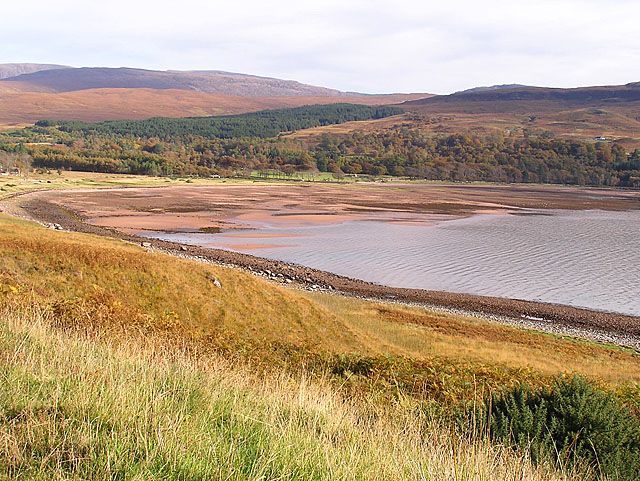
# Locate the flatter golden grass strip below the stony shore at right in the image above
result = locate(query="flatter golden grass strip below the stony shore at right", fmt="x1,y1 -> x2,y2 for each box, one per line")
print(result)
306,293 -> 640,383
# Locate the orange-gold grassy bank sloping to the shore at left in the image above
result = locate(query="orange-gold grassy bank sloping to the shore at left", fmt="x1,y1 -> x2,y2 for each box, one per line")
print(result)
0,217 -> 356,345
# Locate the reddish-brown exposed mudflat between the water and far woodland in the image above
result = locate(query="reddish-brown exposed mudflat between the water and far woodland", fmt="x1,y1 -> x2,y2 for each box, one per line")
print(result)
41,183 -> 640,233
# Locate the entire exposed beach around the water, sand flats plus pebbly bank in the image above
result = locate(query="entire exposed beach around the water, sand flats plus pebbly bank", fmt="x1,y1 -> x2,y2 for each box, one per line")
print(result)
5,185 -> 640,349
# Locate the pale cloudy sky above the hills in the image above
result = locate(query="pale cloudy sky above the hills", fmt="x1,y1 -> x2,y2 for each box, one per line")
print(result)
0,0 -> 640,93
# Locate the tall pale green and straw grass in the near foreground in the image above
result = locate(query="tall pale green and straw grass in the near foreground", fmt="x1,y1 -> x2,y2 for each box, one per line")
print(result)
0,308 -> 584,481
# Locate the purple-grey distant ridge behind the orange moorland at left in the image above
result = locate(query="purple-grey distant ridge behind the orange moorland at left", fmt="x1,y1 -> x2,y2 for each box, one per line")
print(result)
4,68 -> 356,97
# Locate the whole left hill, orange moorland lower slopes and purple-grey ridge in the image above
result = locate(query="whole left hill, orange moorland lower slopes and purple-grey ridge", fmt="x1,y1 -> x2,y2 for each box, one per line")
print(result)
0,64 -> 429,127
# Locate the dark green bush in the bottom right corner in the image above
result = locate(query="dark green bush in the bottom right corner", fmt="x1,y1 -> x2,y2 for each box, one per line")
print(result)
483,377 -> 640,481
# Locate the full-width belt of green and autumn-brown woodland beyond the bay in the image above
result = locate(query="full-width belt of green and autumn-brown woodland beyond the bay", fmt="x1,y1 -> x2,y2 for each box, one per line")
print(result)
0,105 -> 640,188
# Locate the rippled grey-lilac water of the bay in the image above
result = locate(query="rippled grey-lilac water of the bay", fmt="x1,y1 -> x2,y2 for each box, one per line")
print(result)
145,211 -> 640,315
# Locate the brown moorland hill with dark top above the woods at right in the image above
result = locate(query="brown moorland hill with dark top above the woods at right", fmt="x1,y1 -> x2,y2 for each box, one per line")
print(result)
392,82 -> 640,150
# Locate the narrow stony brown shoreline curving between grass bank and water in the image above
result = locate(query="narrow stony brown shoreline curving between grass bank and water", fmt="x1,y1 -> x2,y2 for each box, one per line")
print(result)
5,191 -> 640,351
